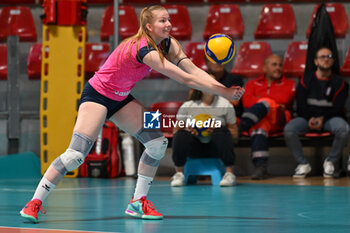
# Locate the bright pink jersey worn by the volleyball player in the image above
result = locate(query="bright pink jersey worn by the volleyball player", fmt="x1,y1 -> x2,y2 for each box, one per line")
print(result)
89,38 -> 151,101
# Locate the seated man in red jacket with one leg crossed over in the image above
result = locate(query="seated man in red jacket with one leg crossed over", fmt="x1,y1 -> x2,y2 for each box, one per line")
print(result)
239,54 -> 295,179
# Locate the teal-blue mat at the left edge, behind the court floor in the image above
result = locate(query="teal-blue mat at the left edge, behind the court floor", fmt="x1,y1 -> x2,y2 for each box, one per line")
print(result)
0,152 -> 41,179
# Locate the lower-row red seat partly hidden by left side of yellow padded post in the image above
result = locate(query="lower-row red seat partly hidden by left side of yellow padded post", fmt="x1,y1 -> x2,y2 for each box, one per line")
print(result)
27,44 -> 42,80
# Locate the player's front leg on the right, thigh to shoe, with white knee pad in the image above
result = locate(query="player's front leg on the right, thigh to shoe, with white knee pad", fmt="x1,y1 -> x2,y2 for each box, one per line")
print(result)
111,100 -> 168,219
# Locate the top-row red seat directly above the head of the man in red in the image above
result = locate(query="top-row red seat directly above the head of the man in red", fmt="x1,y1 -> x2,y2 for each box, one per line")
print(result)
254,4 -> 297,39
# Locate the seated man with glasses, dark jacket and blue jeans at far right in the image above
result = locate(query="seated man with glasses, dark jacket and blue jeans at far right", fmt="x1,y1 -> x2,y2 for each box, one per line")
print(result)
284,47 -> 350,178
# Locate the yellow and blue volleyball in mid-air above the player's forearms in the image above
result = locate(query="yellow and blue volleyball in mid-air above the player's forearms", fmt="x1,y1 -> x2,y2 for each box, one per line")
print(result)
204,34 -> 236,65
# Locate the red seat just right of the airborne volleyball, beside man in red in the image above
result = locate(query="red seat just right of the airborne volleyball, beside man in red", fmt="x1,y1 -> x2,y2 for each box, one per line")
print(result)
231,41 -> 272,77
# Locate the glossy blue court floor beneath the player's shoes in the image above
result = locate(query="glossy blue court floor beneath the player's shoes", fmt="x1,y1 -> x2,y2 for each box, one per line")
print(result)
0,178 -> 350,233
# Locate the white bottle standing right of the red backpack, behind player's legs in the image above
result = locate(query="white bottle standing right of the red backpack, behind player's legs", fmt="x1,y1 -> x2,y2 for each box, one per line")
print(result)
122,134 -> 136,176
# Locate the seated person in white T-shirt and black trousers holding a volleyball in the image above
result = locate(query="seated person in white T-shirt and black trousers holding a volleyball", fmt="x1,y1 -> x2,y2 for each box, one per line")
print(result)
171,78 -> 238,186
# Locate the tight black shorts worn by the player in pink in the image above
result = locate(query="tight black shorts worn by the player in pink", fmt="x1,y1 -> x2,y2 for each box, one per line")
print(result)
80,82 -> 135,119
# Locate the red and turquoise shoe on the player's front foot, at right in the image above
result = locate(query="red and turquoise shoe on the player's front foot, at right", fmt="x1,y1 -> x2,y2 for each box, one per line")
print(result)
125,196 -> 163,219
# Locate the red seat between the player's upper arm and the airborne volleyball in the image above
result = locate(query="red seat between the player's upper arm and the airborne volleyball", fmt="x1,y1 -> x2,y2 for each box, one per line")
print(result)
185,42 -> 208,70
